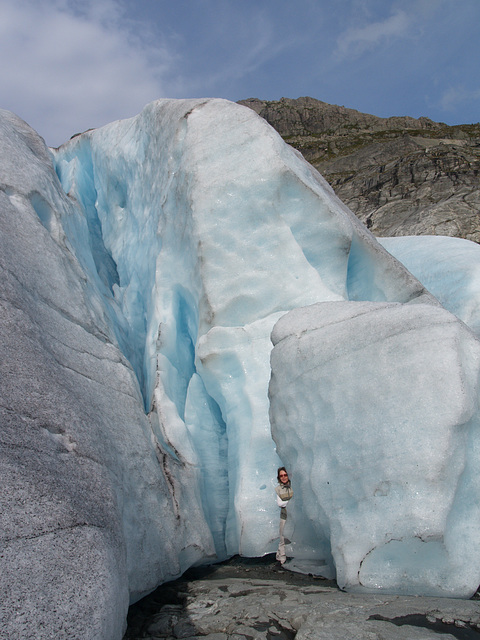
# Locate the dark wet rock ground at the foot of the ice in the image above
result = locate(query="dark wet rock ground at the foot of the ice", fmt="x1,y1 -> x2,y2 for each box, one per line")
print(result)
124,556 -> 480,640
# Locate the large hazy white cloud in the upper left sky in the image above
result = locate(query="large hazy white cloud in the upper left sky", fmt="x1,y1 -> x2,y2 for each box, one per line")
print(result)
0,0 -> 175,145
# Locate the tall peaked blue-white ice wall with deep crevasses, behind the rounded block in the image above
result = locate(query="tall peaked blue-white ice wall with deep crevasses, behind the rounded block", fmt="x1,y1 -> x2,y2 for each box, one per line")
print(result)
51,100 -> 428,557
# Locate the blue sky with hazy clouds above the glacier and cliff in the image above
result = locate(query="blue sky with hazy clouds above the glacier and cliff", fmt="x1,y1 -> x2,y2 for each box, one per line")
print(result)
0,0 -> 480,147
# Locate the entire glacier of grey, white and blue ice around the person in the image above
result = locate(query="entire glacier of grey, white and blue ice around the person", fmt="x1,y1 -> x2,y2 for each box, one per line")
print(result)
0,99 -> 480,638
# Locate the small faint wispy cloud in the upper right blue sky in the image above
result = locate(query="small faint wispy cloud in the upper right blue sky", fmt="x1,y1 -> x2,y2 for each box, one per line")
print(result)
334,11 -> 409,60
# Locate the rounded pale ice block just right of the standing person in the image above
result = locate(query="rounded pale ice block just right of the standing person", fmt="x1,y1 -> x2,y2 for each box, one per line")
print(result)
270,302 -> 480,597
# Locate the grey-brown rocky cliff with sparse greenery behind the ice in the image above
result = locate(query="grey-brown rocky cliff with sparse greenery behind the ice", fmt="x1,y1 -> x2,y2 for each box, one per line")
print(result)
240,97 -> 480,242
